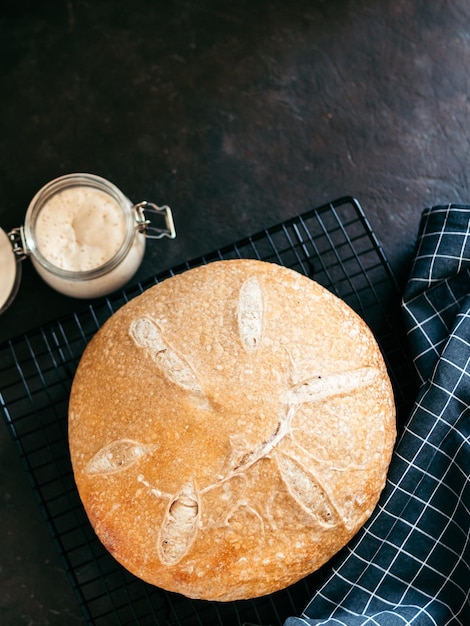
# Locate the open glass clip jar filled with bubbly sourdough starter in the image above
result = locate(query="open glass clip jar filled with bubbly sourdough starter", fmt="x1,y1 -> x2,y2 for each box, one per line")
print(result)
3,173 -> 176,308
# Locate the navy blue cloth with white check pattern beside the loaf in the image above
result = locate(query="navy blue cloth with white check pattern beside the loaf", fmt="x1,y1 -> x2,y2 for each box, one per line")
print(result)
285,205 -> 470,626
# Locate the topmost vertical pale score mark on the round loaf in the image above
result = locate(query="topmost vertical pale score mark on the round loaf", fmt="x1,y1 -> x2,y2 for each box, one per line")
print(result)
237,276 -> 264,352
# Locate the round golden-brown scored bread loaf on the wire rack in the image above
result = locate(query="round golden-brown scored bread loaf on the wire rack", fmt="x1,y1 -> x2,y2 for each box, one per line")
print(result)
69,260 -> 395,601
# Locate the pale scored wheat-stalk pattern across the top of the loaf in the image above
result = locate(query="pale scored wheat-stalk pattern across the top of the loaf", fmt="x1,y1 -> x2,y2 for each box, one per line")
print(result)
86,277 -> 380,565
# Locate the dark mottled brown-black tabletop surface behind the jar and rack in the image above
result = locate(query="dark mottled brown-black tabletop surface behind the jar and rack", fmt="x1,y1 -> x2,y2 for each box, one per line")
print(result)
0,0 -> 470,625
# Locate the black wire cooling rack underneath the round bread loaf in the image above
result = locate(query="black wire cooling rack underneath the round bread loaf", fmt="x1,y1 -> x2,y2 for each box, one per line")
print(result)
0,198 -> 414,626
